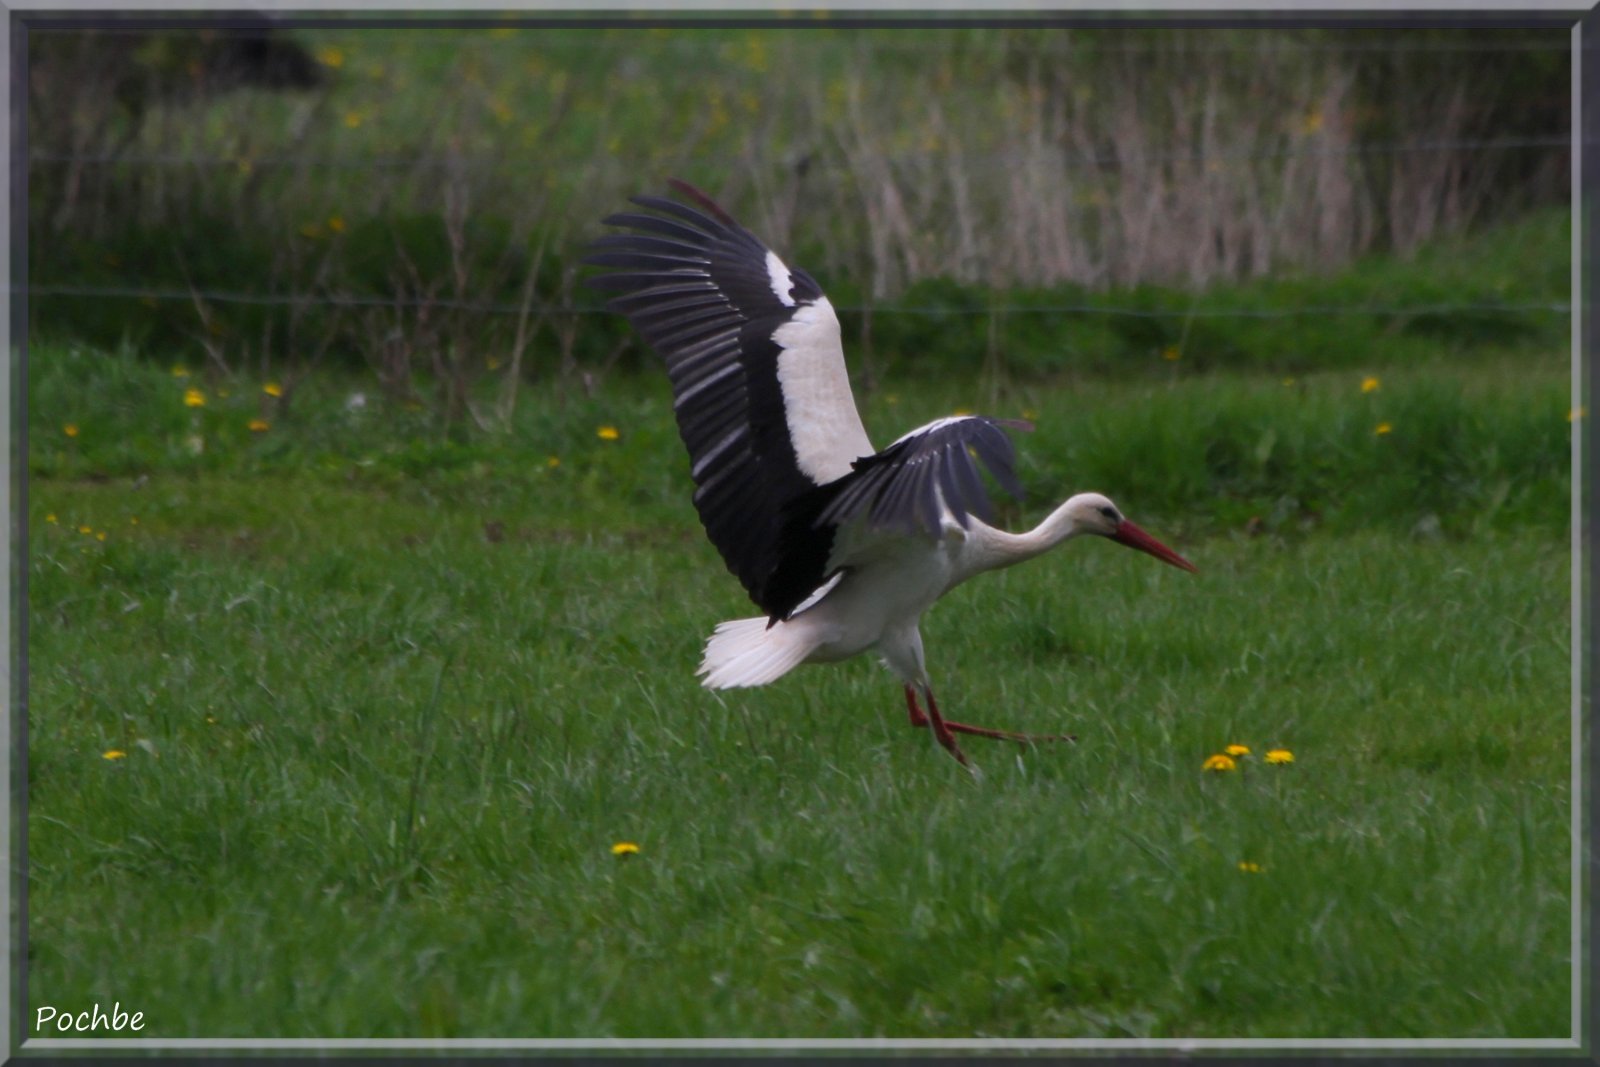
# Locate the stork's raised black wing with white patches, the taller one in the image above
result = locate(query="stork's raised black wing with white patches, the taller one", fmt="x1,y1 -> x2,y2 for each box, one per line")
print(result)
586,181 -> 872,619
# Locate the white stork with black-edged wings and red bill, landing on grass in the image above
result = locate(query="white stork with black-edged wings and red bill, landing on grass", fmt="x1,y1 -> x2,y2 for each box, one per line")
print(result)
586,179 -> 1195,765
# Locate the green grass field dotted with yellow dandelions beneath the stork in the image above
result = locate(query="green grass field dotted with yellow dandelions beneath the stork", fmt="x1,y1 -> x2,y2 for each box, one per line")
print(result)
27,326 -> 1571,1038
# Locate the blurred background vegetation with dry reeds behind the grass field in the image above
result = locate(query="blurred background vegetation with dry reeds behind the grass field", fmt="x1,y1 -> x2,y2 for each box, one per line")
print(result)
29,18 -> 1570,415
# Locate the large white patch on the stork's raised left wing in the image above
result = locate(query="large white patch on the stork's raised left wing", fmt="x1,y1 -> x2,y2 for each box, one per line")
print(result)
768,299 -> 874,485
